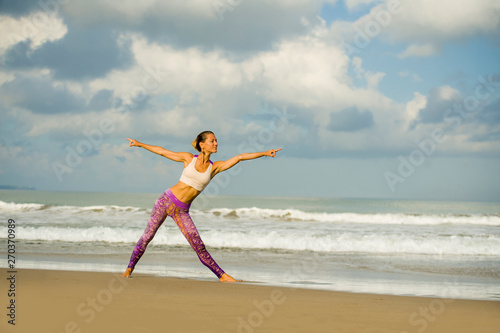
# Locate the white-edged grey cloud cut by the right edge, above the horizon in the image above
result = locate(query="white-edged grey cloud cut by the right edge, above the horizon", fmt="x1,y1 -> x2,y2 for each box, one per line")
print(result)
399,81 -> 500,156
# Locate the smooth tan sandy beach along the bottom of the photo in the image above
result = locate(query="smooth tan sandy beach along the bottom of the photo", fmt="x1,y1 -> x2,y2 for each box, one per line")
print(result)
0,269 -> 500,333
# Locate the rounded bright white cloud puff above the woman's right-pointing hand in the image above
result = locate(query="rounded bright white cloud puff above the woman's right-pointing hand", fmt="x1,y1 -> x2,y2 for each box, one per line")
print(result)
256,37 -> 351,107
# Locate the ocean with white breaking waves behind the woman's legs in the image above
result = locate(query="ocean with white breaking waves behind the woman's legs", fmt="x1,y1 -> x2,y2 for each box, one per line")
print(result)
0,190 -> 500,300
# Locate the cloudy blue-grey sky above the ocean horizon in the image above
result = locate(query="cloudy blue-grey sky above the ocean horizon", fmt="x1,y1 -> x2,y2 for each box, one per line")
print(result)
0,0 -> 500,202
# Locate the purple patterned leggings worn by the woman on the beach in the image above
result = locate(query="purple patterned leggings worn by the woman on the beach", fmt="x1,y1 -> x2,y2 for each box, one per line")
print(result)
128,189 -> 224,278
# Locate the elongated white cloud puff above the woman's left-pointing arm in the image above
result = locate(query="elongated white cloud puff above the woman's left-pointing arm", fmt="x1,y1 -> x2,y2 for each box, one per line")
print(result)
91,35 -> 246,106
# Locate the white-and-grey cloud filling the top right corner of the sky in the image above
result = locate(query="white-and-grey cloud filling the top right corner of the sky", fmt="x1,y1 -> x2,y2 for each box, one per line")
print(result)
330,0 -> 500,59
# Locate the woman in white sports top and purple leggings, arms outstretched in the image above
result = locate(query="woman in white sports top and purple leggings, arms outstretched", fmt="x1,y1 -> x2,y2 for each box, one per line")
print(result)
121,131 -> 281,282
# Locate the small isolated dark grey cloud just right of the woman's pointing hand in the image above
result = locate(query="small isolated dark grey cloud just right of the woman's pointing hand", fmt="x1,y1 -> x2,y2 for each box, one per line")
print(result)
327,107 -> 374,132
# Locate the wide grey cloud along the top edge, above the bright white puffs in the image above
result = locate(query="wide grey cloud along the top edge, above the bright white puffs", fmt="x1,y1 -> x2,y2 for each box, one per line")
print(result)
64,0 -> 336,52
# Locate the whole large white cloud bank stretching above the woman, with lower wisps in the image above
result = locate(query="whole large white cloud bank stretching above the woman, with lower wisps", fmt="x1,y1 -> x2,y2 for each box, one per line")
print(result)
85,27 -> 410,154
